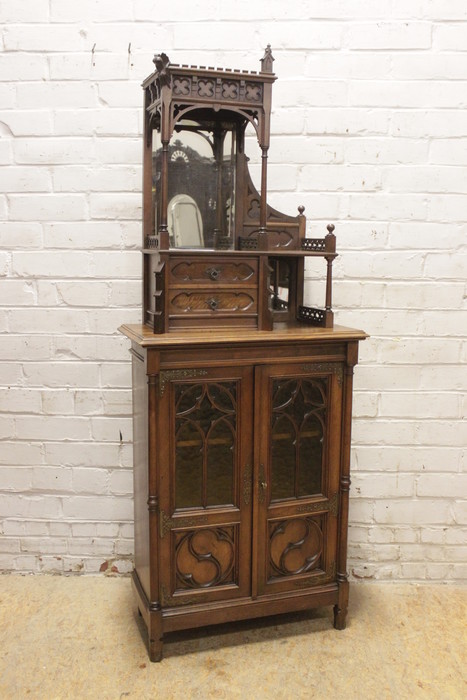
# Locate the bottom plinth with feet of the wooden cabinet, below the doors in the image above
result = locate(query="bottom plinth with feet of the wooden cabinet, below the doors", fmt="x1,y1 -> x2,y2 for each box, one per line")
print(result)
132,571 -> 349,662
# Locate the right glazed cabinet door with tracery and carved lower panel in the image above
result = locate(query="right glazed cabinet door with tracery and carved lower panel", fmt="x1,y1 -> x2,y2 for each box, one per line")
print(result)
255,363 -> 343,596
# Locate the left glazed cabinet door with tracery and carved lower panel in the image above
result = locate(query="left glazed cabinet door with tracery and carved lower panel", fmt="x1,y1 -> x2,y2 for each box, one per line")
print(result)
157,367 -> 253,607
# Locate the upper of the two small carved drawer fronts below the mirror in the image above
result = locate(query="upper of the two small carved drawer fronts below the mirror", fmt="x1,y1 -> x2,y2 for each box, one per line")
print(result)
170,258 -> 258,288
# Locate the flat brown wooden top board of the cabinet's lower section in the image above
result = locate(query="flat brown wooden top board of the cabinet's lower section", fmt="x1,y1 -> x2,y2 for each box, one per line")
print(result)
119,324 -> 368,348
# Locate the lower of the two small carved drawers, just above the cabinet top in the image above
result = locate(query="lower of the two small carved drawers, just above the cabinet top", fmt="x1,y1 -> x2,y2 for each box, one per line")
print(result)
169,289 -> 258,316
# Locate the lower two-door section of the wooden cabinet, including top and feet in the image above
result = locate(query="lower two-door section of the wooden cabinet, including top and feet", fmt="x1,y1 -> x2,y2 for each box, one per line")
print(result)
122,326 -> 365,661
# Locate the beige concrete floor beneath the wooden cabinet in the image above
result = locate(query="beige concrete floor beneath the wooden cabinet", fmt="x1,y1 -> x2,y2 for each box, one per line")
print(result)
0,575 -> 467,700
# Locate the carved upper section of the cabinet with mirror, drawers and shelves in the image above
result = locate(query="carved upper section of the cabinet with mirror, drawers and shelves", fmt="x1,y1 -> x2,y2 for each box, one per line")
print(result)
143,46 -> 336,333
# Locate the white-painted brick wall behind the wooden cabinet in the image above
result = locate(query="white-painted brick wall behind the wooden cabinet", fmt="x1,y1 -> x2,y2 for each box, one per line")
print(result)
0,0 -> 467,581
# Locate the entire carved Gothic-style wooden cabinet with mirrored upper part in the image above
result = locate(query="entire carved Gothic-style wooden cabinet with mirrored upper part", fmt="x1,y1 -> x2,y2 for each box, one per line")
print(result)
121,49 -> 366,661
